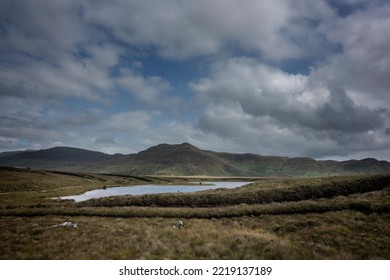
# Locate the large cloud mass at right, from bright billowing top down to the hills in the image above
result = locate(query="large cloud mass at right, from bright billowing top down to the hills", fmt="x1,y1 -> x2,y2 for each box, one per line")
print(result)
190,55 -> 390,156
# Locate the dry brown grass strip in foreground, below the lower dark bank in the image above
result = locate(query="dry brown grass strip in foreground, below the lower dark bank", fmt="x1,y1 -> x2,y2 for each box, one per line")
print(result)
0,211 -> 390,259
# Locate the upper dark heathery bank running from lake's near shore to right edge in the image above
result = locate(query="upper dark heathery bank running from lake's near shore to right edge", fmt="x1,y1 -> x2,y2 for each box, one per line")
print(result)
79,176 -> 390,207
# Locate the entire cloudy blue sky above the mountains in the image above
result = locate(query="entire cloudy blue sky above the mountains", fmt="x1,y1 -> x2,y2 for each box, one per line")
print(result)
0,0 -> 390,160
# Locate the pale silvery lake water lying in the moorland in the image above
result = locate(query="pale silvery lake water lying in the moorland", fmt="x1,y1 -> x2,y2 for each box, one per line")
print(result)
61,182 -> 251,202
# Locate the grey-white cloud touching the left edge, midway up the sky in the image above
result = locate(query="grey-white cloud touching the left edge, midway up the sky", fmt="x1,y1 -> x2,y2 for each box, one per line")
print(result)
0,54 -> 113,101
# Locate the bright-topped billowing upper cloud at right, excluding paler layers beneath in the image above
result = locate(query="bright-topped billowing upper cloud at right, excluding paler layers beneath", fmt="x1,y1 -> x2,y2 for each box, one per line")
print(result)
191,58 -> 383,131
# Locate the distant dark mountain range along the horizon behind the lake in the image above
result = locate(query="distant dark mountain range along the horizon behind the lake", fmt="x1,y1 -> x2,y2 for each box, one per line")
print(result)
0,143 -> 390,176
